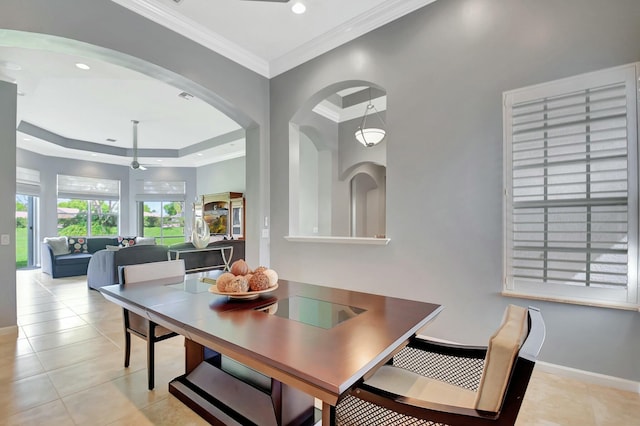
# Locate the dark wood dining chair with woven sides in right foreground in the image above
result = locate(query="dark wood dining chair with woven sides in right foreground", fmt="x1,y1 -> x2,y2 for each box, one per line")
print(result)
331,305 -> 545,426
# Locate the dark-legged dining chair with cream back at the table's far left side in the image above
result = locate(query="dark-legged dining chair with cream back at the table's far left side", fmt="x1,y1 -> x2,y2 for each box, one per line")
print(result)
119,259 -> 185,390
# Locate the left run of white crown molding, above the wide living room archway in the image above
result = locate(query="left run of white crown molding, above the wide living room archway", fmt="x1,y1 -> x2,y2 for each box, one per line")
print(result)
111,0 -> 269,77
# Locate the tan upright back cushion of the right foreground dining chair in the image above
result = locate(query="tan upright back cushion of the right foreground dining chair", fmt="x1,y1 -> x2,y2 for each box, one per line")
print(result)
475,305 -> 529,413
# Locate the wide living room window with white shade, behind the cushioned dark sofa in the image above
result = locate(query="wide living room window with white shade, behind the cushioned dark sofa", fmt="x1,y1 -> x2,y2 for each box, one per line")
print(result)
58,175 -> 120,236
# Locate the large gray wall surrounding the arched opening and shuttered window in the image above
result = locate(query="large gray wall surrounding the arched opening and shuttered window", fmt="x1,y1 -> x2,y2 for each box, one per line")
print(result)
271,0 -> 640,380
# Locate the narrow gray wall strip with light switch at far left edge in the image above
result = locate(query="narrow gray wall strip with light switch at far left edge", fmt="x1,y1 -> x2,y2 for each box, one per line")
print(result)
0,81 -> 17,333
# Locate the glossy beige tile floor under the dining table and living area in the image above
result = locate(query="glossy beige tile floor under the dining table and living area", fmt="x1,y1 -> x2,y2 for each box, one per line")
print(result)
0,270 -> 640,426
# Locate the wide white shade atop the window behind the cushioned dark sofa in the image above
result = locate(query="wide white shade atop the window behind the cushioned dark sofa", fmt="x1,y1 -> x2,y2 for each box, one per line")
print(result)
58,175 -> 120,201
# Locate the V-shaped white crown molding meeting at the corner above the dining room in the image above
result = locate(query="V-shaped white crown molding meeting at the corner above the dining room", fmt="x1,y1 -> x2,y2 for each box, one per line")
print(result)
111,0 -> 436,78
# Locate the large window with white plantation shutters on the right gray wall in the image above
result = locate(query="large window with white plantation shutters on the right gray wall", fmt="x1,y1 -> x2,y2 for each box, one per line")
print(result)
504,64 -> 638,308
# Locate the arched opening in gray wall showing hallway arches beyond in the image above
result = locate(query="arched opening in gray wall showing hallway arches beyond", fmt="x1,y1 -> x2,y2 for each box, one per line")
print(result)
286,80 -> 388,244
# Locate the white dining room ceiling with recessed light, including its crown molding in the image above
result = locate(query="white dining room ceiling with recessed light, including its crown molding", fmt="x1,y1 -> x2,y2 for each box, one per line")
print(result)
112,0 -> 435,78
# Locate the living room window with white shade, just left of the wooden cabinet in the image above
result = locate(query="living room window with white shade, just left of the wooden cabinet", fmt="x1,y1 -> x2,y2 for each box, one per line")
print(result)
136,180 -> 186,245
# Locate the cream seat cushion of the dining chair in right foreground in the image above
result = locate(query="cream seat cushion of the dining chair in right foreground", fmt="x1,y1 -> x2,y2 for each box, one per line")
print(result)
365,365 -> 476,408
